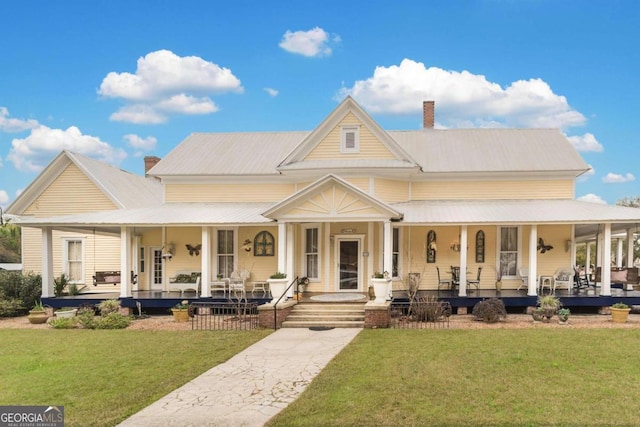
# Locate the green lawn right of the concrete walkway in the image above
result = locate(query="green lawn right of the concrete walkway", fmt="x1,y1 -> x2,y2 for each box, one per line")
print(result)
269,329 -> 640,427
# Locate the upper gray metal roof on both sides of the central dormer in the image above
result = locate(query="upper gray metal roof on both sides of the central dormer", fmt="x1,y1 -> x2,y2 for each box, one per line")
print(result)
150,129 -> 589,177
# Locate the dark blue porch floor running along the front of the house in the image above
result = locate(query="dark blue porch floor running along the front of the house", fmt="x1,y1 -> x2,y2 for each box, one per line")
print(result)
42,287 -> 640,309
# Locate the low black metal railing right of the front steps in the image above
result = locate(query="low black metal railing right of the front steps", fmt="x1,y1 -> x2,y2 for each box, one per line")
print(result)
389,299 -> 453,329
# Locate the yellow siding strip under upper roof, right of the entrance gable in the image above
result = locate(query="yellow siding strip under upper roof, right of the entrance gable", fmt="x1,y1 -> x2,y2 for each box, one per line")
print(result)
411,180 -> 574,200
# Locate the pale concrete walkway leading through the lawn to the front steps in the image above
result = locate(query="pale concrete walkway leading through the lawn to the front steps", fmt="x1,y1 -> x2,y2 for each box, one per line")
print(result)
120,328 -> 361,427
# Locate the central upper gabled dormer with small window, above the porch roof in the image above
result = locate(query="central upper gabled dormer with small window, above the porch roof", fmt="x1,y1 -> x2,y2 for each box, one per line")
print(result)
278,96 -> 418,171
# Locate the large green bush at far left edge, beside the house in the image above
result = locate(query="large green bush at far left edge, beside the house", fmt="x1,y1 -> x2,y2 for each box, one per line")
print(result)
0,271 -> 42,317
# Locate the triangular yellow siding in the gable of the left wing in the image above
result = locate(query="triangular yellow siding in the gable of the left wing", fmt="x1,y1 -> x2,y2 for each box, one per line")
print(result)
25,164 -> 117,217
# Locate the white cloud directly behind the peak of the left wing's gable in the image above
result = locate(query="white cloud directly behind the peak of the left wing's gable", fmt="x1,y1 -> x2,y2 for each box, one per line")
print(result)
7,125 -> 127,172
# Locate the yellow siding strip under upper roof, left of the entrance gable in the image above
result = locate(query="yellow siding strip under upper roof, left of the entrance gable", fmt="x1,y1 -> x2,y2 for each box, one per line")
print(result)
165,183 -> 295,203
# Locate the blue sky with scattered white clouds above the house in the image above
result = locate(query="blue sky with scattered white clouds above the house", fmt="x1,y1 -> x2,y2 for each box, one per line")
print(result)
0,0 -> 640,207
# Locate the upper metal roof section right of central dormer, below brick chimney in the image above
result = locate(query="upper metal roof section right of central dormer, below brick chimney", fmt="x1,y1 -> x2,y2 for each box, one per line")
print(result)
389,128 -> 589,172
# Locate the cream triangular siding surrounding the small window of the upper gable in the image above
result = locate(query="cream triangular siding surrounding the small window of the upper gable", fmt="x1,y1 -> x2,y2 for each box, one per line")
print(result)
306,113 -> 395,160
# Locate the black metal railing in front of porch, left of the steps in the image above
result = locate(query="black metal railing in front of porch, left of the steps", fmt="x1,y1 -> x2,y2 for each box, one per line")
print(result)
189,299 -> 258,331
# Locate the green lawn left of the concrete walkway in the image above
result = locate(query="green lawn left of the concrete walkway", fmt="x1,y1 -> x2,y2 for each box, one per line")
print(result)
0,329 -> 272,426
